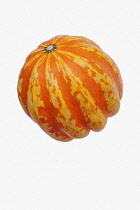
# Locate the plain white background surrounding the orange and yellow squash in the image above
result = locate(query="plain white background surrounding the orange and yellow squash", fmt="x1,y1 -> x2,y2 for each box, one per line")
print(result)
0,0 -> 140,210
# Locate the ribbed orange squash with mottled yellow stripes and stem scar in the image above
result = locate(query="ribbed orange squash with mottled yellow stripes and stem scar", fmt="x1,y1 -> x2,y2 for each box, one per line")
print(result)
18,35 -> 122,141
